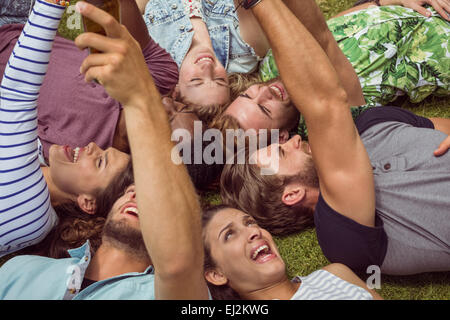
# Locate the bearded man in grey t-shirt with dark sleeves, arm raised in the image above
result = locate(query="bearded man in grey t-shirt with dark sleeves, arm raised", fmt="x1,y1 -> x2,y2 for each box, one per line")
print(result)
221,0 -> 450,275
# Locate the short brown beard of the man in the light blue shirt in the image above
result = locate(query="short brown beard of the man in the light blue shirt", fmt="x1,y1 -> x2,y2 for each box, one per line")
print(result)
102,219 -> 150,261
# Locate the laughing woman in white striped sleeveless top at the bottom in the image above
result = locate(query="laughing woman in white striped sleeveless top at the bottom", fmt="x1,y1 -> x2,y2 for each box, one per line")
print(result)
203,205 -> 381,300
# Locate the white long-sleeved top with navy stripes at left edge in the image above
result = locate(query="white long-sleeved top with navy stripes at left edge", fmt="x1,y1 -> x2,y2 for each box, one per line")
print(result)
0,0 -> 65,257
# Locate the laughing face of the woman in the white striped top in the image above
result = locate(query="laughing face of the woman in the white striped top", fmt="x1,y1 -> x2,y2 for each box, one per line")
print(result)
204,209 -> 286,294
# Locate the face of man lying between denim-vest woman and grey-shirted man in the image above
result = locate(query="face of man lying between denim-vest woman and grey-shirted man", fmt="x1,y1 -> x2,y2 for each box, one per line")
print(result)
225,80 -> 298,130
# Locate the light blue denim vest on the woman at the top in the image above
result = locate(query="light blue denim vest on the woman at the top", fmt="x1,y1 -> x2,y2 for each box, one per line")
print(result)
144,0 -> 261,73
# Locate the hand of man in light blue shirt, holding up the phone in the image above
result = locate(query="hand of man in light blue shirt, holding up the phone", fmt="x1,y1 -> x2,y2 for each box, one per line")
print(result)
75,1 -> 154,106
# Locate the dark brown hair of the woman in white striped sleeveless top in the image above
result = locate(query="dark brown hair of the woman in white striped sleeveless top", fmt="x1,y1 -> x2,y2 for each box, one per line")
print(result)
202,205 -> 241,300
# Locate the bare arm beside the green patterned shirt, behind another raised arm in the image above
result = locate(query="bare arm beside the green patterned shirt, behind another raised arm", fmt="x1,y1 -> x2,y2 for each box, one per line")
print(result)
283,0 -> 366,106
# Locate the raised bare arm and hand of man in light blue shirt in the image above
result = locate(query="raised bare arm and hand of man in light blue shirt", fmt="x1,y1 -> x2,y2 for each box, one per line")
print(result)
76,2 -> 208,299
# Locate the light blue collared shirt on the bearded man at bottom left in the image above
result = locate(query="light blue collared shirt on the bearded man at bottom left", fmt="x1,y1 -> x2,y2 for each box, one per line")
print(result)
0,242 -> 155,300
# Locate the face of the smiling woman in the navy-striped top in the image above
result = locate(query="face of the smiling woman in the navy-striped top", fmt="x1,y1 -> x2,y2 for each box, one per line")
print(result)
49,142 -> 130,202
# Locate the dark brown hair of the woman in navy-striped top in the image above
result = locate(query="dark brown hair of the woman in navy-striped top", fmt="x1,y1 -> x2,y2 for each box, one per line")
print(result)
24,160 -> 134,259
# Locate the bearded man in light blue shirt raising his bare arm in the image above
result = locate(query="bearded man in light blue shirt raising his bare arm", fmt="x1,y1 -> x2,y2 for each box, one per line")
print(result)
0,0 -> 208,300
